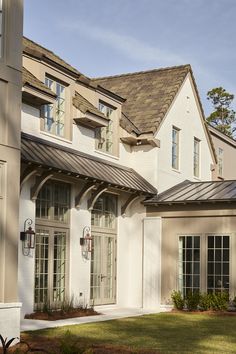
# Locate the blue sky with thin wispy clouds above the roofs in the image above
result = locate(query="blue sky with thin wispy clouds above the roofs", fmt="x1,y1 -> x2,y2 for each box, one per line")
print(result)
24,0 -> 236,116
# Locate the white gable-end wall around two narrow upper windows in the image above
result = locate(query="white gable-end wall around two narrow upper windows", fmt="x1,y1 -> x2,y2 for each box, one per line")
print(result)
157,76 -> 213,192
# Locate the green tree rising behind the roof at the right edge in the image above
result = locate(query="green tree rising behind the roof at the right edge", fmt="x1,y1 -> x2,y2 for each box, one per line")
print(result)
206,87 -> 236,137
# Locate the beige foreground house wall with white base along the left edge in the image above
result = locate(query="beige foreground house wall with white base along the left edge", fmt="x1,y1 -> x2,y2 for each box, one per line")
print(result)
0,0 -> 23,338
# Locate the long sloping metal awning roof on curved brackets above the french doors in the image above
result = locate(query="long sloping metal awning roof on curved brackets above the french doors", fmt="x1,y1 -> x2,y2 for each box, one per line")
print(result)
21,133 -> 157,195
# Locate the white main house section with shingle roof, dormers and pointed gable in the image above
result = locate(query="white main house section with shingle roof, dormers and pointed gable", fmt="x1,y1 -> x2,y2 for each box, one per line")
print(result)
18,38 -> 221,316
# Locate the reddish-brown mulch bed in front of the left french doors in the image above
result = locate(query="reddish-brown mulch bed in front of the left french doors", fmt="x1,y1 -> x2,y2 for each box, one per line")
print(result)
25,309 -> 100,321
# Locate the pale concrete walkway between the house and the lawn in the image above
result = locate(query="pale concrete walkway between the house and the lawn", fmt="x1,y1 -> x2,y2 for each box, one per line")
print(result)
21,306 -> 160,332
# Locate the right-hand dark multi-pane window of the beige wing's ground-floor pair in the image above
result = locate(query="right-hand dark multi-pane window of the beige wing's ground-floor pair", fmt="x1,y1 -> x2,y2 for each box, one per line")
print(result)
207,236 -> 230,293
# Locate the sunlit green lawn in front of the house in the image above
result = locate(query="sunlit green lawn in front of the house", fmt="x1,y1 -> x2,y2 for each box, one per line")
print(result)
23,313 -> 236,354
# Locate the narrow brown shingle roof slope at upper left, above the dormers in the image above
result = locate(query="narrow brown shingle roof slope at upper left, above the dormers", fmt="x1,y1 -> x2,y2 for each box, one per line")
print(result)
23,37 -> 85,77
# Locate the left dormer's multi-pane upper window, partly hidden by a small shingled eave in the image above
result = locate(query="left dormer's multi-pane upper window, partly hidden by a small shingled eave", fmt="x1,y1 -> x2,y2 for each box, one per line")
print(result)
44,77 -> 65,137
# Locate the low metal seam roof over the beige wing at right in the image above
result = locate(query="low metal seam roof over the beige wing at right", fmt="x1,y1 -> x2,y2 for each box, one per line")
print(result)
144,180 -> 236,206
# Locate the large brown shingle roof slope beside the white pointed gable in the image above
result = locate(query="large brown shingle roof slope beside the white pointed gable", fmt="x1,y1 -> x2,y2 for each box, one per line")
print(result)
93,65 -> 191,133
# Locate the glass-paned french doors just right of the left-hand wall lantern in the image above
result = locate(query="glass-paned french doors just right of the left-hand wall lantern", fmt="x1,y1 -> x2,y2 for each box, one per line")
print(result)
34,226 -> 68,309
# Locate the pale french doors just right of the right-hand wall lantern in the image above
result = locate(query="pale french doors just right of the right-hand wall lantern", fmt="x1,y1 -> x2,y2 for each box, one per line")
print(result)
90,232 -> 116,305
